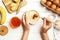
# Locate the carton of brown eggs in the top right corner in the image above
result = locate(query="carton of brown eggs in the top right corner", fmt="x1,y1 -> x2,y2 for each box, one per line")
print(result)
40,0 -> 60,15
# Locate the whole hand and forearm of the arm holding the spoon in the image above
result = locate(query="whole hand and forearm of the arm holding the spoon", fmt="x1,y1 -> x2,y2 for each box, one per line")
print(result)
41,18 -> 52,40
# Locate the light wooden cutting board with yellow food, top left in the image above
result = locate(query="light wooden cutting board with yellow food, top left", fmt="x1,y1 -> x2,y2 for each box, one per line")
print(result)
2,0 -> 20,13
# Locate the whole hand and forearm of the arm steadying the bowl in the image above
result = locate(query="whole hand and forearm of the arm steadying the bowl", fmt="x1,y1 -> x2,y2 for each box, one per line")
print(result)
21,14 -> 30,40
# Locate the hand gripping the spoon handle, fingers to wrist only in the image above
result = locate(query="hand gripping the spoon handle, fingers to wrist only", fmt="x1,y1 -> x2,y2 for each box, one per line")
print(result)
41,18 -> 52,33
